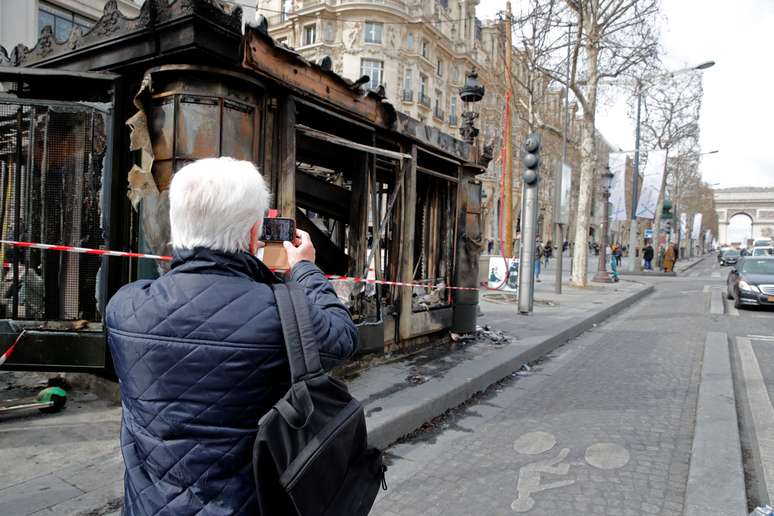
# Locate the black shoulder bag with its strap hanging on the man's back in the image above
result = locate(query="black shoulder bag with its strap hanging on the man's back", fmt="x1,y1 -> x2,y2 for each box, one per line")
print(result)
253,283 -> 386,516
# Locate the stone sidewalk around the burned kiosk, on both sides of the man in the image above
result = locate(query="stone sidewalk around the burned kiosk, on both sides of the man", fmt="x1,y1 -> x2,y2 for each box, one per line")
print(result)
0,269 -> 652,516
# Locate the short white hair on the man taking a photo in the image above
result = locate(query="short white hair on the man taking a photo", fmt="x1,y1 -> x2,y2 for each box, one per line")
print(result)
169,158 -> 270,253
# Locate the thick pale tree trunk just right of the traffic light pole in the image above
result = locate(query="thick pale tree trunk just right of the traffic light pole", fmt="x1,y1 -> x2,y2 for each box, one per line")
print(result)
572,46 -> 599,287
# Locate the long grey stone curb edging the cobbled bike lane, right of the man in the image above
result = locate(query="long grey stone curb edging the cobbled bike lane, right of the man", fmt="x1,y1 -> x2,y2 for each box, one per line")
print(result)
366,285 -> 654,449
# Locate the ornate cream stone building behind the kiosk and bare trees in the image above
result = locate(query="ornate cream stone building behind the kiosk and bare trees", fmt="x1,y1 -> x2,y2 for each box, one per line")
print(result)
264,0 -> 612,254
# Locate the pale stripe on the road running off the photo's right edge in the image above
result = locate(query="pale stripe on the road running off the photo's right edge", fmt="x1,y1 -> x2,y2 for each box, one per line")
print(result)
736,337 -> 774,506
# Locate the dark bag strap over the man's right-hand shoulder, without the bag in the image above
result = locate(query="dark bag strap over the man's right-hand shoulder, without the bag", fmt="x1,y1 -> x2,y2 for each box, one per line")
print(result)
271,282 -> 322,383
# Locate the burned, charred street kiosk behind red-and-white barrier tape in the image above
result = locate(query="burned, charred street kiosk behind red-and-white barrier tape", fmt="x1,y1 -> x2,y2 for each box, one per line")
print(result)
0,0 -> 491,371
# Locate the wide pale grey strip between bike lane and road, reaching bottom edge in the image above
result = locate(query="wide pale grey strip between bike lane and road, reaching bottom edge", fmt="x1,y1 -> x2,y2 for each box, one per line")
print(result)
684,332 -> 747,516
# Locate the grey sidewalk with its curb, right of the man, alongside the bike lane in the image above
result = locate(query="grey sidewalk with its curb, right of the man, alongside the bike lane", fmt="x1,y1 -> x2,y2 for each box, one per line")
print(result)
350,284 -> 653,448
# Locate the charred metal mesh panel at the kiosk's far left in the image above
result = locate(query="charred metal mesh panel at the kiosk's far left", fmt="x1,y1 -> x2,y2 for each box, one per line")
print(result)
0,103 -> 106,320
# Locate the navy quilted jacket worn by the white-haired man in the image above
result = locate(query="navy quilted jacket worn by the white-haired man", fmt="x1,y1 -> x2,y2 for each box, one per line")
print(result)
106,248 -> 357,516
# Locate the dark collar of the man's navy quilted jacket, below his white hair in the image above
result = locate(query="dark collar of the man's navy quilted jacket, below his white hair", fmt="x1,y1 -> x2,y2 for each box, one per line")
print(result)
170,247 -> 280,283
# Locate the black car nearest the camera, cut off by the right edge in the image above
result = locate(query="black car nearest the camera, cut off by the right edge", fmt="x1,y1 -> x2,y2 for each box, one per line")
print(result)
726,256 -> 774,308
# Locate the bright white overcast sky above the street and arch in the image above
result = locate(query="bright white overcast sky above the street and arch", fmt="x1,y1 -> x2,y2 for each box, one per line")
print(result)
477,0 -> 774,188
